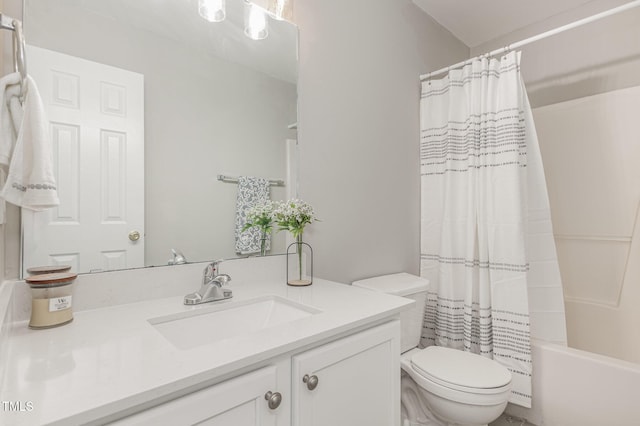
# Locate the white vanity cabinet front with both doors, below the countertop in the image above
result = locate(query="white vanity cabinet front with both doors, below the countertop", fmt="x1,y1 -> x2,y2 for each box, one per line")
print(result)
111,321 -> 400,426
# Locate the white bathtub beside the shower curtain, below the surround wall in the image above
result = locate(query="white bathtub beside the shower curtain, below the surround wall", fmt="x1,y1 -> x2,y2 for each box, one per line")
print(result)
506,341 -> 640,426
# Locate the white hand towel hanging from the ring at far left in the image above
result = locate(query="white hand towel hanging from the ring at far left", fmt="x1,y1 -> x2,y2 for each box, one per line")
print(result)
0,75 -> 60,211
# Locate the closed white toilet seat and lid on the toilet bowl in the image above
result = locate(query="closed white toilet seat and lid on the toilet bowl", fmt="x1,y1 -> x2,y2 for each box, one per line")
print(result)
402,346 -> 511,405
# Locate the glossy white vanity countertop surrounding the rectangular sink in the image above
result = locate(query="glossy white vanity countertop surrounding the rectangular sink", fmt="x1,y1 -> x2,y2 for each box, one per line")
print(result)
0,279 -> 413,425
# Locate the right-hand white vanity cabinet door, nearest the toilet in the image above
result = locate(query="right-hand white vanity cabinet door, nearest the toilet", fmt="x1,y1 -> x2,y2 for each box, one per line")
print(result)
292,321 -> 400,426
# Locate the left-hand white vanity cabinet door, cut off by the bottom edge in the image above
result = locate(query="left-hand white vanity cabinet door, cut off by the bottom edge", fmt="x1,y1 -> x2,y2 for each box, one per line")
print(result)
113,366 -> 282,426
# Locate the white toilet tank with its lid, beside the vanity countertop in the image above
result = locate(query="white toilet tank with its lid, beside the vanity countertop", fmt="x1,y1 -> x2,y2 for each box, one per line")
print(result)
352,272 -> 429,352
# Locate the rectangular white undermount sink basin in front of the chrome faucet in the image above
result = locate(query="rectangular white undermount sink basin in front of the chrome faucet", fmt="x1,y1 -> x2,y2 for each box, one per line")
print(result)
148,296 -> 321,349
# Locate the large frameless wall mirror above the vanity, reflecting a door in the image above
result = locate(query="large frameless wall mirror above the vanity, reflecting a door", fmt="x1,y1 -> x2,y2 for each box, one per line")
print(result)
22,0 -> 298,275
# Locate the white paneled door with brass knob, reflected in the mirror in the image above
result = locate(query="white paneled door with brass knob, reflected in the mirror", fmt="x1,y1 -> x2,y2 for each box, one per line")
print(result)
22,46 -> 144,276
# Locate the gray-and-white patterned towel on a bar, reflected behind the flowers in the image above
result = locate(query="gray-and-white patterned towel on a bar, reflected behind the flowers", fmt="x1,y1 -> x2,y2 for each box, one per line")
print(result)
235,176 -> 270,254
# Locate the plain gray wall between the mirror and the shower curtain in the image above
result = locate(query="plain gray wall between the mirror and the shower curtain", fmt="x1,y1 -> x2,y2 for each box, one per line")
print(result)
294,0 -> 469,282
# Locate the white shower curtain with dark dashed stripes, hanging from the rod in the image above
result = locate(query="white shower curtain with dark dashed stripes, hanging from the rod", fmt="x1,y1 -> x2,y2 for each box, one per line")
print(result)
420,52 -> 546,407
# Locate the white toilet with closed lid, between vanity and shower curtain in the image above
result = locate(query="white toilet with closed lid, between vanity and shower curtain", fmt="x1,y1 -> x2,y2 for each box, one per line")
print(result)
353,273 -> 511,426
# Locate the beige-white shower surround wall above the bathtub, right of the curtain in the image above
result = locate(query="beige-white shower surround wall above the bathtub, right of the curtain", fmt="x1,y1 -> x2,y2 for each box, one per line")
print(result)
534,86 -> 640,362
